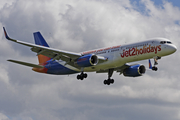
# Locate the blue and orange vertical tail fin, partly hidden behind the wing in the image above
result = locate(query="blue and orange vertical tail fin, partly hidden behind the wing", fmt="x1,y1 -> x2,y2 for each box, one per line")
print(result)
33,32 -> 51,64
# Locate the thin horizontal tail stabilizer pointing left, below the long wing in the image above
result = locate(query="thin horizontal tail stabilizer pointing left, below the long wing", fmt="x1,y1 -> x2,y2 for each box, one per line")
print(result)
7,60 -> 44,68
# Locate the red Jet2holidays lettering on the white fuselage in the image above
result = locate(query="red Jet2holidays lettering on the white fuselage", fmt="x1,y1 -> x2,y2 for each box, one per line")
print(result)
121,45 -> 161,58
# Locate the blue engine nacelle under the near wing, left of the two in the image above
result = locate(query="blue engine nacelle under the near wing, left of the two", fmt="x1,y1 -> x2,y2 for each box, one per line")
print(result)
75,54 -> 98,67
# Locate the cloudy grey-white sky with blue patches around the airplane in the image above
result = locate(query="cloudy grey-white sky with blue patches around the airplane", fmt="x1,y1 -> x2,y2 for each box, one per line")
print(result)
0,0 -> 180,120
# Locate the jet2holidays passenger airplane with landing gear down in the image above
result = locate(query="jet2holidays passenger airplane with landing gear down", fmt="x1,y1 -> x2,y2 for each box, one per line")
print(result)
3,27 -> 177,85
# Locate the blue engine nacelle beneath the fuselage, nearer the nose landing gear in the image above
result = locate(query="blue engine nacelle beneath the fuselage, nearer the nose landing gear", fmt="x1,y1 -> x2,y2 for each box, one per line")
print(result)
123,64 -> 146,77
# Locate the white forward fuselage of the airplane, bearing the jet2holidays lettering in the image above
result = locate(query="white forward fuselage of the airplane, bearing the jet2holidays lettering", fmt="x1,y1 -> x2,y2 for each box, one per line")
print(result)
71,38 -> 176,72
